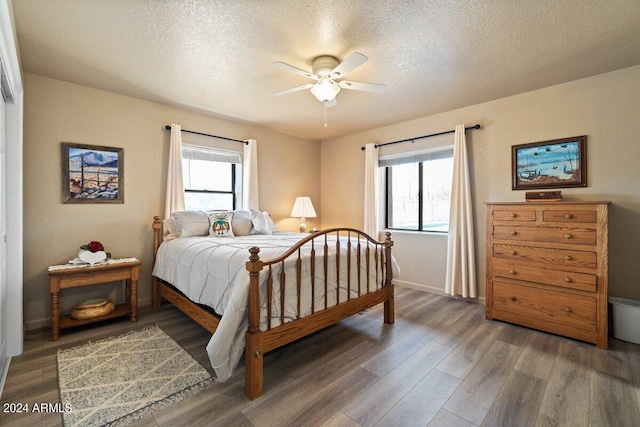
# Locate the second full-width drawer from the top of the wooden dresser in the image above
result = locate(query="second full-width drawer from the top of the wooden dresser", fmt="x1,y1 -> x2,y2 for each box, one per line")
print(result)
493,245 -> 598,270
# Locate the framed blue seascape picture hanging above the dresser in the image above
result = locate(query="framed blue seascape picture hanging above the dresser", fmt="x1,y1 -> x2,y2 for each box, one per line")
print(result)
511,135 -> 587,190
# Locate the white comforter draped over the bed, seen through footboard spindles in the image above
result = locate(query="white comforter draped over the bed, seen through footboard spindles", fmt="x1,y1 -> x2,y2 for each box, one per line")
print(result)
153,232 -> 398,382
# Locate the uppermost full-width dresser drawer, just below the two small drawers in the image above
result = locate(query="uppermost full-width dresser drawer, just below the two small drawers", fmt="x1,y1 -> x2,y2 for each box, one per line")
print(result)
493,224 -> 597,245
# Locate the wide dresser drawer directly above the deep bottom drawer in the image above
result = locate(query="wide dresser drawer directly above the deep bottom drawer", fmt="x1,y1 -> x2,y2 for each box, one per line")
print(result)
493,259 -> 598,292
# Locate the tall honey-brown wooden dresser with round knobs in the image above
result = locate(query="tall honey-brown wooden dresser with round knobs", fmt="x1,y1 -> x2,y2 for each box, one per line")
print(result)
486,202 -> 610,348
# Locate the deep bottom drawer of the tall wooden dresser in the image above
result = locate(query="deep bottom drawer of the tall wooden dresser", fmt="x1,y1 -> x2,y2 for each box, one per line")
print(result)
493,280 -> 596,331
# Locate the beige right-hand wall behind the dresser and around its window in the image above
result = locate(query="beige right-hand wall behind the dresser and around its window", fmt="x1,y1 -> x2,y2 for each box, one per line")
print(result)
321,66 -> 640,300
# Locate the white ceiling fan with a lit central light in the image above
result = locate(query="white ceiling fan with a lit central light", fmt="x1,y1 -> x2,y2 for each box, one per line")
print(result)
273,52 -> 387,108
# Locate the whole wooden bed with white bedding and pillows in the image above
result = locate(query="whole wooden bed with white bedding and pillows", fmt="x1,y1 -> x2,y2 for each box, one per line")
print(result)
152,211 -> 399,400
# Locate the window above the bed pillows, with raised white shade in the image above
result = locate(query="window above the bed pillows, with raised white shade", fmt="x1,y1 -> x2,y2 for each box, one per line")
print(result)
182,145 -> 242,210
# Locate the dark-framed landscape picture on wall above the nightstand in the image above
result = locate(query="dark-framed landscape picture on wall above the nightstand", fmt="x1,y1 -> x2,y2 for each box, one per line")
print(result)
62,142 -> 124,203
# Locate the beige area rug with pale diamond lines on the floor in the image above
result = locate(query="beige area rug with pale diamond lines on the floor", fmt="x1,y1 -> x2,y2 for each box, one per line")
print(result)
57,326 -> 212,427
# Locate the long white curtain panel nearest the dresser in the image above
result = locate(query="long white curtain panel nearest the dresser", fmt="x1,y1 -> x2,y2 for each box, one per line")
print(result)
445,124 -> 477,298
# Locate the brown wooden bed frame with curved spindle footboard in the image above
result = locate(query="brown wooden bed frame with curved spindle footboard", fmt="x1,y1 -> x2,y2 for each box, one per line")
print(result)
152,216 -> 394,400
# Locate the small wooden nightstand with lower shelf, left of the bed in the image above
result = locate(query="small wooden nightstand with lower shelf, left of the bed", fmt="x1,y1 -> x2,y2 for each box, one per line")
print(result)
49,258 -> 140,341
